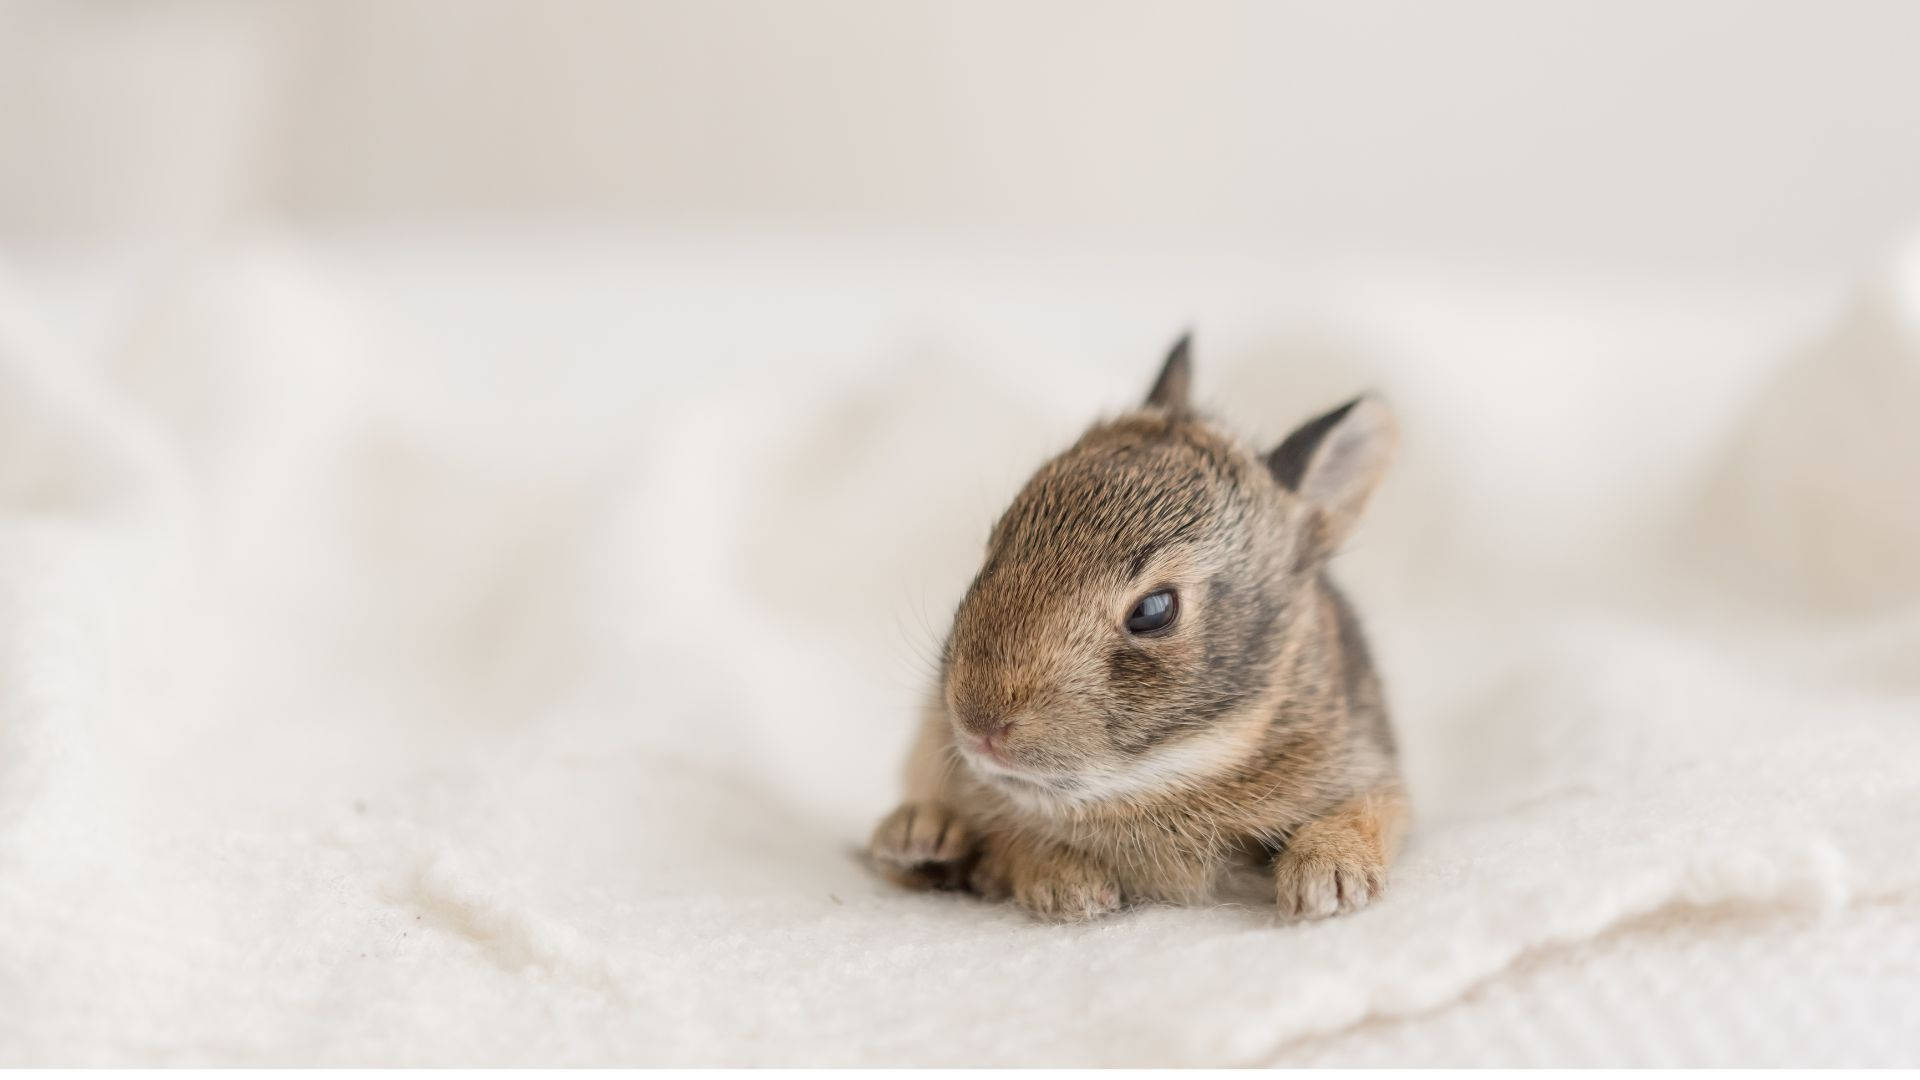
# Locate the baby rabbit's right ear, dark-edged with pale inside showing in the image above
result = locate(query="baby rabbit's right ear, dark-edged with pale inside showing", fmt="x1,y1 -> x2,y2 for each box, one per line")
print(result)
1267,394 -> 1400,553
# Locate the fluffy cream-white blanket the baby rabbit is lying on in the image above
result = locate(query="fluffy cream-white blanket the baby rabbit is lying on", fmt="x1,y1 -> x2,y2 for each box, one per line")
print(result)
0,233 -> 1920,1065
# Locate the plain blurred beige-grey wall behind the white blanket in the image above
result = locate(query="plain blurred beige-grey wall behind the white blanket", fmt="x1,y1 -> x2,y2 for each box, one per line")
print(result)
11,0 -> 1920,269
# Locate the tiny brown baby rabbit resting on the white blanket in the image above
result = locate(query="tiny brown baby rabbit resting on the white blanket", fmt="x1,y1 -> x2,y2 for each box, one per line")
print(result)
870,338 -> 1405,919
